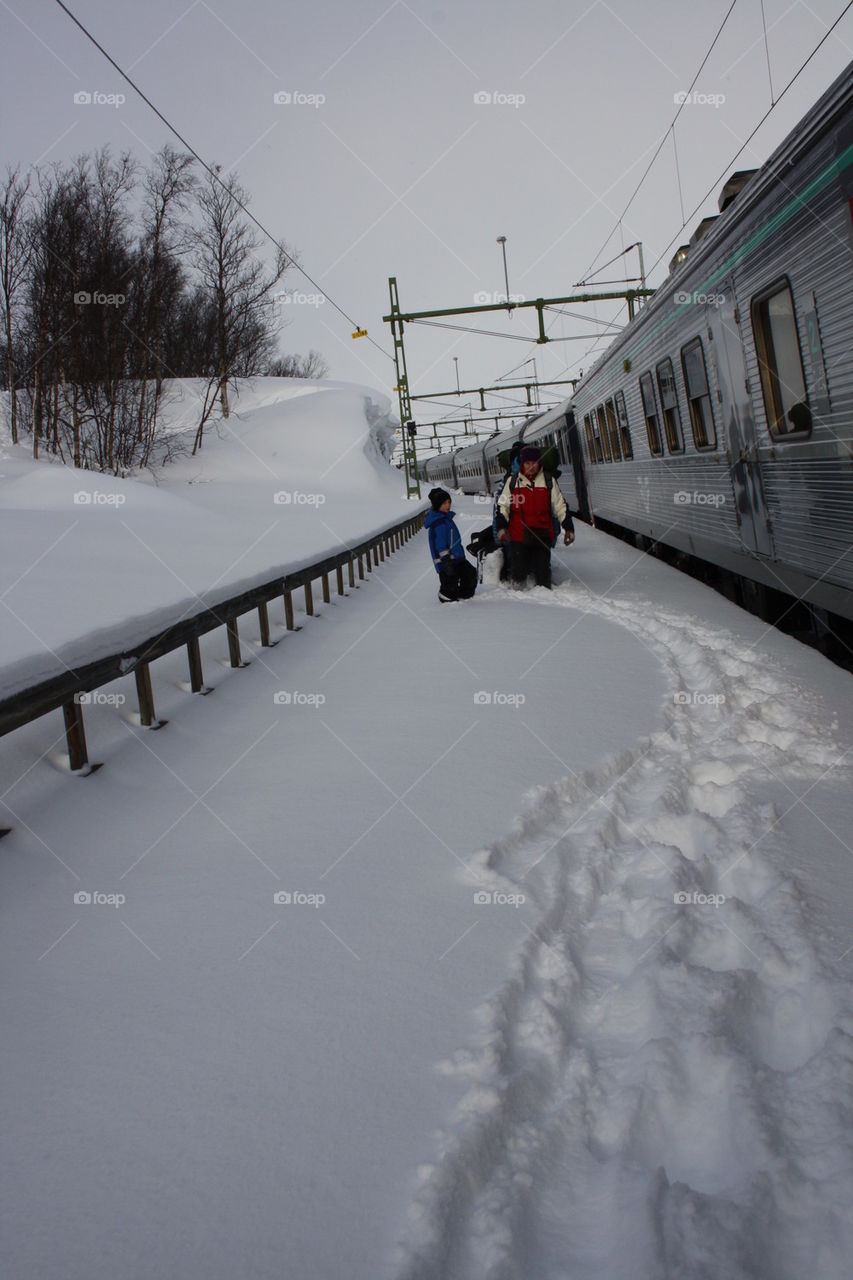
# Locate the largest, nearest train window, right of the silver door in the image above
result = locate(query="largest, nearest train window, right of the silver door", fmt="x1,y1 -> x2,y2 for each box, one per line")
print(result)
752,280 -> 812,435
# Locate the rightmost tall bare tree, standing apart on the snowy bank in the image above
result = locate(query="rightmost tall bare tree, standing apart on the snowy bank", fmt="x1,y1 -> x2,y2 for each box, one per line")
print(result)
193,170 -> 289,453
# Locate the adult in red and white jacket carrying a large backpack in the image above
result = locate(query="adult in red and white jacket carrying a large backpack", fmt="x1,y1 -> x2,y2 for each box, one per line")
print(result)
497,444 -> 575,588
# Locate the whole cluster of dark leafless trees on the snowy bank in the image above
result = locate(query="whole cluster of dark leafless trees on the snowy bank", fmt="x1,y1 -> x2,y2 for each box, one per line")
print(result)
0,146 -> 327,474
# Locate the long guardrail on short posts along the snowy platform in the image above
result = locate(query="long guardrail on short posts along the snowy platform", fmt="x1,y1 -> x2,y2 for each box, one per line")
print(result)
0,512 -> 425,771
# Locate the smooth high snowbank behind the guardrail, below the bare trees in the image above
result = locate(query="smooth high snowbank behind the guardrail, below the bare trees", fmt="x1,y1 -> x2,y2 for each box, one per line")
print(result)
0,378 -> 407,696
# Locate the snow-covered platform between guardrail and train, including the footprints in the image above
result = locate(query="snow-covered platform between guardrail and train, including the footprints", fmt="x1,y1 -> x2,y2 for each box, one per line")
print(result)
0,391 -> 853,1280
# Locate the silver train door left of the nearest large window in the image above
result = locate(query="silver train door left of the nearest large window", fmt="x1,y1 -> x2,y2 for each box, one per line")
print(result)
706,279 -> 772,556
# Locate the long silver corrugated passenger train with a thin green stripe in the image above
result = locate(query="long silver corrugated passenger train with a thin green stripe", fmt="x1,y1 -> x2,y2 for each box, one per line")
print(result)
419,63 -> 853,632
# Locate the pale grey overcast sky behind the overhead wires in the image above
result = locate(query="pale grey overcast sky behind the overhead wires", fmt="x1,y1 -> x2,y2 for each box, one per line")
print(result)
0,0 -> 853,432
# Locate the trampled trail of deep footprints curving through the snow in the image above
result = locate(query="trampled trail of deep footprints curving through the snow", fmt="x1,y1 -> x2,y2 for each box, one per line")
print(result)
394,581 -> 853,1280
